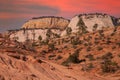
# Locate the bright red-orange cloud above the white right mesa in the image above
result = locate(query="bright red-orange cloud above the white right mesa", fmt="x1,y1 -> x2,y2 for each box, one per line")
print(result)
34,0 -> 120,16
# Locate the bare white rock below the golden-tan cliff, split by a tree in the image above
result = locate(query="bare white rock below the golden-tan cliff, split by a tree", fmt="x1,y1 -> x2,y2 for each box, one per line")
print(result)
10,29 -> 61,42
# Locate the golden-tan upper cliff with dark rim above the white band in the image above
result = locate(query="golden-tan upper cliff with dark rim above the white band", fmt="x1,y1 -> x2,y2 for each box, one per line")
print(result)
22,16 -> 69,30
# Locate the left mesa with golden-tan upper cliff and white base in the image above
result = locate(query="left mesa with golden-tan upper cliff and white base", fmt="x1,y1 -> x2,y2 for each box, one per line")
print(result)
9,16 -> 69,42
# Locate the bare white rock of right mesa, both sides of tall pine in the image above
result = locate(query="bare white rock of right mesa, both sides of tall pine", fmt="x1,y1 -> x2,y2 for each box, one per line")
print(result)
61,14 -> 115,36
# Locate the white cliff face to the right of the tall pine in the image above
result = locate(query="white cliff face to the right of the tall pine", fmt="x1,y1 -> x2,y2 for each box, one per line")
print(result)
82,15 -> 114,32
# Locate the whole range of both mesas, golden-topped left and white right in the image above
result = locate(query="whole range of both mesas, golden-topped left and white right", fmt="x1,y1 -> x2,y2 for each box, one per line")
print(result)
7,13 -> 120,42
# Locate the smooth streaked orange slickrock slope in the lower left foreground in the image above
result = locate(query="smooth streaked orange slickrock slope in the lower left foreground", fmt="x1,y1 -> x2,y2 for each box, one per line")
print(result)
0,49 -> 89,80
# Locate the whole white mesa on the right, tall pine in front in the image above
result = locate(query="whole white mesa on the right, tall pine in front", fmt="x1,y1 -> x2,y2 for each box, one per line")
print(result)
61,13 -> 117,36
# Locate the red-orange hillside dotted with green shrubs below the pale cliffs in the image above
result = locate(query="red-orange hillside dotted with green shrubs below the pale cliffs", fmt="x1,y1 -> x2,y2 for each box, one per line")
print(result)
0,27 -> 120,80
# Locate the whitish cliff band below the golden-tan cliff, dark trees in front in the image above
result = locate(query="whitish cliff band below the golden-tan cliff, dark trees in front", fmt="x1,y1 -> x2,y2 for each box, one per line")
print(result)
10,29 -> 61,42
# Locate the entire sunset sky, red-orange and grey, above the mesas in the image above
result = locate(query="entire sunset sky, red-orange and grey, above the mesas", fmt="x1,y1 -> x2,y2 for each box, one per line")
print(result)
0,0 -> 120,32
